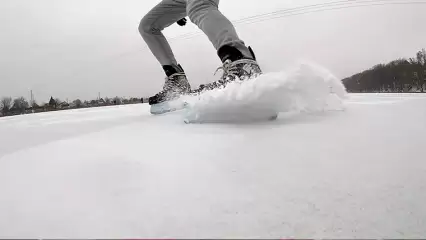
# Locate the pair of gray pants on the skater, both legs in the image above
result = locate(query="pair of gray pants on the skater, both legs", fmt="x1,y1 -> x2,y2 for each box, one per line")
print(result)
139,0 -> 251,65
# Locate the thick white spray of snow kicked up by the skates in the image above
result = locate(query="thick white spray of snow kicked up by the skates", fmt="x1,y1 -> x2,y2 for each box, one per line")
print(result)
185,62 -> 347,122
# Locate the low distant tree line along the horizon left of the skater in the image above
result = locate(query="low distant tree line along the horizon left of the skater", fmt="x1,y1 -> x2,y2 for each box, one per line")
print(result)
0,97 -> 141,117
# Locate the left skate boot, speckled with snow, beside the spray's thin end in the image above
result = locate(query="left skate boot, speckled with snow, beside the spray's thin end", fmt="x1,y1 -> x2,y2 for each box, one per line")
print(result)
148,65 -> 191,114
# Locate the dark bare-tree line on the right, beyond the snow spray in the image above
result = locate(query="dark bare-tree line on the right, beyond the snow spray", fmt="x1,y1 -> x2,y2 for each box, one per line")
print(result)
342,49 -> 426,93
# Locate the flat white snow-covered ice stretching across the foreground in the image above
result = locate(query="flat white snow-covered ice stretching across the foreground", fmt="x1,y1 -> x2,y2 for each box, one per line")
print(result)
0,94 -> 426,238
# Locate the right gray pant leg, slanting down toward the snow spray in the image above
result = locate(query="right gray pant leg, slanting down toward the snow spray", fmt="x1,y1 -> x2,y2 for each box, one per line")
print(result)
187,0 -> 252,60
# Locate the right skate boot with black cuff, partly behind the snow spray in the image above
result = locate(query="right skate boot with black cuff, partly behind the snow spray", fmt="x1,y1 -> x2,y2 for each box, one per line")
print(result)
196,46 -> 262,92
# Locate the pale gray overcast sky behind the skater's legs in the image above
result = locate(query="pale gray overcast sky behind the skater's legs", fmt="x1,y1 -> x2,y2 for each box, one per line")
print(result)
0,0 -> 426,102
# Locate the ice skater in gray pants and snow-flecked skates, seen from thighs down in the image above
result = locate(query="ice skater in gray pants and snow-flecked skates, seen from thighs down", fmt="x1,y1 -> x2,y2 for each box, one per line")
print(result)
139,0 -> 261,105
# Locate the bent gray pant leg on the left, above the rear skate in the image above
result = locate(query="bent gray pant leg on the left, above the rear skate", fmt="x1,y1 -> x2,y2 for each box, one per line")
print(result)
139,0 -> 186,66
